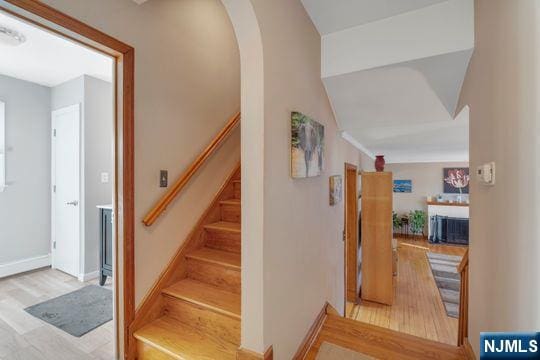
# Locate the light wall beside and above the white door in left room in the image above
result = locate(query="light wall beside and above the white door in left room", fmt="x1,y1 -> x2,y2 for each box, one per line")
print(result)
51,75 -> 114,280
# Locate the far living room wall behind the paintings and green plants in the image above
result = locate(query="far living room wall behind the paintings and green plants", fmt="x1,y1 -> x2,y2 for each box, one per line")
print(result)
385,163 -> 469,215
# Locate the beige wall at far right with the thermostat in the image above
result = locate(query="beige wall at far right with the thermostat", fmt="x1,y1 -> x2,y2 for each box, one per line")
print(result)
461,0 -> 540,354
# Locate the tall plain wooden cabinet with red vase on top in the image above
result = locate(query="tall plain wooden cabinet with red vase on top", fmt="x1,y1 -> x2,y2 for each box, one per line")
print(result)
361,172 -> 394,305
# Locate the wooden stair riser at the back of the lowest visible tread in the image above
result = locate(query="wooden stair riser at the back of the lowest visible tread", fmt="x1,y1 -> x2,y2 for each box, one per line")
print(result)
164,296 -> 240,346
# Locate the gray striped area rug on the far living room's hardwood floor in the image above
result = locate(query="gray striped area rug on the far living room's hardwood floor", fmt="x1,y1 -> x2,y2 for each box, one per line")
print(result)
427,252 -> 461,318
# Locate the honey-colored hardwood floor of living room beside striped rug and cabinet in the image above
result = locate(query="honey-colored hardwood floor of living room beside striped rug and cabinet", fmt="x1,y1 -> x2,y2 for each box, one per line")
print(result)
346,238 -> 466,345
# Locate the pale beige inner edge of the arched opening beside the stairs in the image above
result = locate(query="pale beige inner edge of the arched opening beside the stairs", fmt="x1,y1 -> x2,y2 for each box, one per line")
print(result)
221,0 -> 267,353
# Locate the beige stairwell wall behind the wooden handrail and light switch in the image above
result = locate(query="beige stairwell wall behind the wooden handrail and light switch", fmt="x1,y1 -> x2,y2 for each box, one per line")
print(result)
38,0 -> 240,304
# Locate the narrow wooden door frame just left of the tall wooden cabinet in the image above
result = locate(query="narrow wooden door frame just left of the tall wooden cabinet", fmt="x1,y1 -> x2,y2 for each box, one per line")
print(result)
343,163 -> 359,310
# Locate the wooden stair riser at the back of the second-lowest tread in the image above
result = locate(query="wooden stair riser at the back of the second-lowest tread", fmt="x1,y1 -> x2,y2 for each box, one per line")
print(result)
188,259 -> 241,294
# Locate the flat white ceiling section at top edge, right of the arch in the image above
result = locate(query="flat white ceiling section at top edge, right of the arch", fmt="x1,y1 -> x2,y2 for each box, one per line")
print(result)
302,0 -> 446,35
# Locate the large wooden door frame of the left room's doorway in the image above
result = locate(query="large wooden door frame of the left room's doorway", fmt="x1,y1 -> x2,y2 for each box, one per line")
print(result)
0,0 -> 135,359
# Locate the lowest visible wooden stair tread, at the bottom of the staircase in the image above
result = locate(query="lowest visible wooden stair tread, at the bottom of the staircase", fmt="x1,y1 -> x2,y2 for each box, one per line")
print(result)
134,316 -> 237,360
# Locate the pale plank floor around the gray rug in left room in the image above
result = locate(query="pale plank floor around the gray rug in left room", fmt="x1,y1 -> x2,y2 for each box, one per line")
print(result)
0,268 -> 114,360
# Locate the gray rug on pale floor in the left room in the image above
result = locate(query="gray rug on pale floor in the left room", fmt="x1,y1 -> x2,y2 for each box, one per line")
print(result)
24,285 -> 113,337
